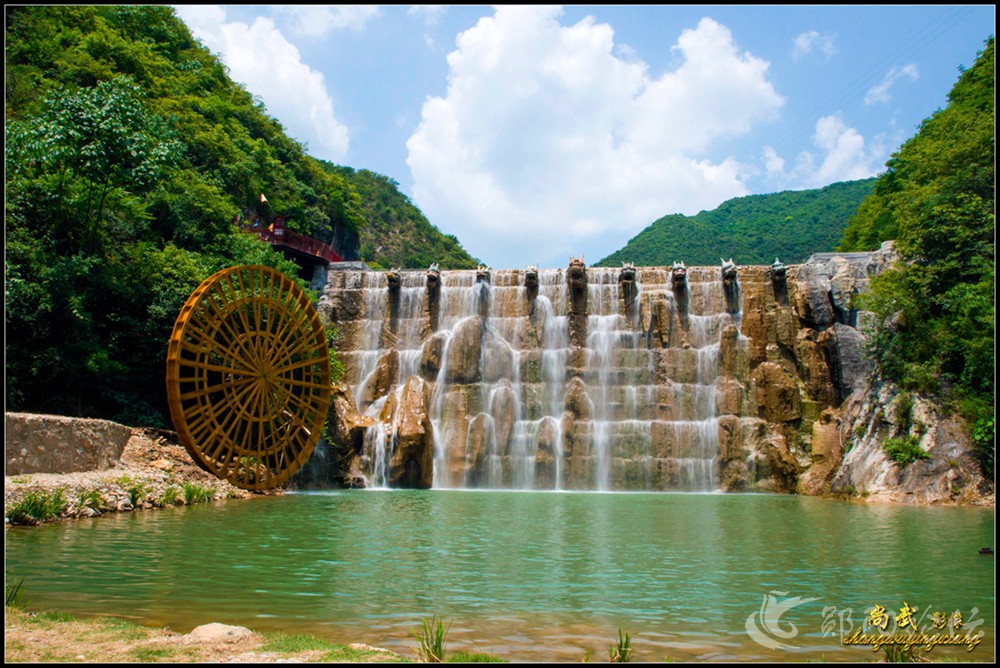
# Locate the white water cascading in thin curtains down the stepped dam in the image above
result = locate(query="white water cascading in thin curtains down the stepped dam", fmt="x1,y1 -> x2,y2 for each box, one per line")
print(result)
344,268 -> 742,491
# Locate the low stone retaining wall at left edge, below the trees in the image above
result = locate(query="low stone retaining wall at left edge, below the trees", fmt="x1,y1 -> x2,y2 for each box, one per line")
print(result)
4,413 -> 132,476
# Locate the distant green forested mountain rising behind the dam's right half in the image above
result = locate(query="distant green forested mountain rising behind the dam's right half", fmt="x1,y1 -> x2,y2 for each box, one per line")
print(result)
597,179 -> 875,267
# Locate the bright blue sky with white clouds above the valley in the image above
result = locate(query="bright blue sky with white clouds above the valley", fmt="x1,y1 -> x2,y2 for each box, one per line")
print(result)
177,5 -> 996,269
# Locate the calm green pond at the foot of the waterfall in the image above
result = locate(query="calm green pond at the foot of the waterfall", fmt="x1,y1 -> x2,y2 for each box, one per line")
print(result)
5,490 -> 995,662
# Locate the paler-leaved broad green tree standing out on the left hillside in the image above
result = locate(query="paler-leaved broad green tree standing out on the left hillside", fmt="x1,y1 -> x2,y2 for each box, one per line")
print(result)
6,77 -> 181,253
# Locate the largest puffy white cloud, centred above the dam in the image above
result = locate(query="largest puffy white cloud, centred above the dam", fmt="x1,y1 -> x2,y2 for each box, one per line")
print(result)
407,6 -> 784,267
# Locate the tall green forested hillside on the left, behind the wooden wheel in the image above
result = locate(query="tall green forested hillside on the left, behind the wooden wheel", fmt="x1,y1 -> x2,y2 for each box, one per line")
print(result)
4,5 -> 474,425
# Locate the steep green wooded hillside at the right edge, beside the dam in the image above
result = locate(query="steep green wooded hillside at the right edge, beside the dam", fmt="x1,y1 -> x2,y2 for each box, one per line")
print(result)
840,38 -> 996,472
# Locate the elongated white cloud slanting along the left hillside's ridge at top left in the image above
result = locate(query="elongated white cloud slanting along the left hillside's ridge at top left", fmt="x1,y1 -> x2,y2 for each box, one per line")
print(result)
176,6 -> 350,162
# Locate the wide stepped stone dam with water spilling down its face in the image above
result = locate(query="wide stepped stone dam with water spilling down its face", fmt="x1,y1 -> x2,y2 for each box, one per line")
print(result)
314,251 -> 900,492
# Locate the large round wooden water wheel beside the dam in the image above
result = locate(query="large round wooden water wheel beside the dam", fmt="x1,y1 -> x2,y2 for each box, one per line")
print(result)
167,266 -> 330,490
